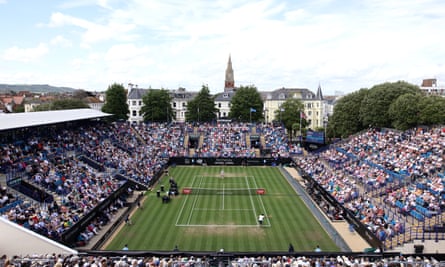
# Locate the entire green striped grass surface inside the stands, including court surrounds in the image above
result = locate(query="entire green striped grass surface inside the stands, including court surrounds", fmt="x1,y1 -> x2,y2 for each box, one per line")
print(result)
106,166 -> 339,252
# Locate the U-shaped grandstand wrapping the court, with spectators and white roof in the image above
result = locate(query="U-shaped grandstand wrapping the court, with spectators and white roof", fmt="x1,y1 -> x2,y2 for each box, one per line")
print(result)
0,110 -> 445,262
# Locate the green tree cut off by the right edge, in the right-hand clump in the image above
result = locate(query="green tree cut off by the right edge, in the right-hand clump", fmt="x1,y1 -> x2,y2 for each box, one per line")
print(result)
419,96 -> 445,125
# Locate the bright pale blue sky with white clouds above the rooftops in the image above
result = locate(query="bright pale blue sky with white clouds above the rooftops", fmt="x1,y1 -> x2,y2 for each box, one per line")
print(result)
0,0 -> 445,95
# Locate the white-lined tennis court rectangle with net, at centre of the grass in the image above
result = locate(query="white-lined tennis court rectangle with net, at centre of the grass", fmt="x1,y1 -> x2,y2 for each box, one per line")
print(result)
176,176 -> 270,227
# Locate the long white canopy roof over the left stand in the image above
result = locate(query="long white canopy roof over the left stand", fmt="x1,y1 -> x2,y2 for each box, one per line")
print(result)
0,108 -> 112,131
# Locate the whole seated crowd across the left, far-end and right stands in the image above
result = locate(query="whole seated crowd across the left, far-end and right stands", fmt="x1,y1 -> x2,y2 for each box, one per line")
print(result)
0,122 -> 445,253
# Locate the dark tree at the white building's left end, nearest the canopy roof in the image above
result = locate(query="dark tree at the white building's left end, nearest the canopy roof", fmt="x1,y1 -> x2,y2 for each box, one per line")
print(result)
102,83 -> 128,120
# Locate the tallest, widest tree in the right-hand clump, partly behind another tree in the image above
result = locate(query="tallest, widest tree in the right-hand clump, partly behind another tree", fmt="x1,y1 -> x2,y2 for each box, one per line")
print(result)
360,81 -> 421,127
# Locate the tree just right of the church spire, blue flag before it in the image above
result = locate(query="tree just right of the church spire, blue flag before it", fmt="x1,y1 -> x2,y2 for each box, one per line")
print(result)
229,86 -> 264,122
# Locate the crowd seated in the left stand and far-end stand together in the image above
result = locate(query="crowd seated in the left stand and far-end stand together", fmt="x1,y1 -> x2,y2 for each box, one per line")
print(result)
0,122 -> 294,249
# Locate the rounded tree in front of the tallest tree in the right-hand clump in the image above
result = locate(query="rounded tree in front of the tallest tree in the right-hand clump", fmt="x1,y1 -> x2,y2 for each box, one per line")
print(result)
388,94 -> 423,131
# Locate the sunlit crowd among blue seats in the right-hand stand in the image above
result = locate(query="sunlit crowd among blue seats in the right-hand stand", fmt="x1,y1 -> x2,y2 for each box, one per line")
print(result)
296,128 -> 445,246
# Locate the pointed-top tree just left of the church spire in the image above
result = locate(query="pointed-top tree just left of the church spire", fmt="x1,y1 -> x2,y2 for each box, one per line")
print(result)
185,85 -> 218,122
